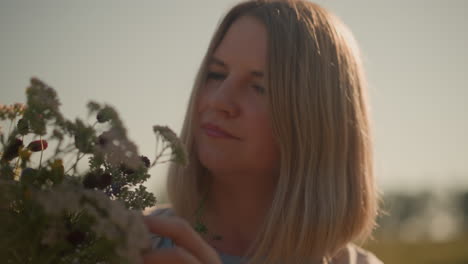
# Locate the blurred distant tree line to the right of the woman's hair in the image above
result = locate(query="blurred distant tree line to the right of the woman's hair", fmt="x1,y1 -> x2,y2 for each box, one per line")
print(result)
374,189 -> 468,242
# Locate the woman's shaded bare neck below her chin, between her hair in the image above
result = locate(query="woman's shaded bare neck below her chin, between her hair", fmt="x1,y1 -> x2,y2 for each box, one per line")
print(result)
202,171 -> 275,255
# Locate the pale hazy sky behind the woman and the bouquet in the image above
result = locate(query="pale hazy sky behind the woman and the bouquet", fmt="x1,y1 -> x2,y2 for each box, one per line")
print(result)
0,0 -> 468,194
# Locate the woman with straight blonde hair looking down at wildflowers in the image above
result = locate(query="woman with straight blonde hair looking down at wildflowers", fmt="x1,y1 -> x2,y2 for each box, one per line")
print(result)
145,0 -> 381,263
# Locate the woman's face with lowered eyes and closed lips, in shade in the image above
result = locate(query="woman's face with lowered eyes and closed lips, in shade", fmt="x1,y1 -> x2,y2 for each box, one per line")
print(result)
194,16 -> 279,177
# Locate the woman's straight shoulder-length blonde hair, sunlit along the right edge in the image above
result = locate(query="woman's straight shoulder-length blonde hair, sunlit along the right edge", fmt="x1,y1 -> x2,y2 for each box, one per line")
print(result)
167,0 -> 378,263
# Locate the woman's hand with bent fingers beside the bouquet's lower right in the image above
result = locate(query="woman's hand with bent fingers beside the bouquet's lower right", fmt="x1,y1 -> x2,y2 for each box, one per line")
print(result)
143,216 -> 221,264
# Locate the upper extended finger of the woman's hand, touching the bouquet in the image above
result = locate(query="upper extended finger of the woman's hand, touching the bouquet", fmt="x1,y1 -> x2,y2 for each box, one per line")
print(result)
144,216 -> 221,264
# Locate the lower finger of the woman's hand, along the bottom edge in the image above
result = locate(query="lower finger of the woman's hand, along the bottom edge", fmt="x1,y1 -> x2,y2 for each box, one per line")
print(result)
143,247 -> 201,264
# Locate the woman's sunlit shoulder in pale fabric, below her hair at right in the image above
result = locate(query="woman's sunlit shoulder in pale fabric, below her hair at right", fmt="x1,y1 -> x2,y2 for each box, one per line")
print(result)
331,244 -> 383,264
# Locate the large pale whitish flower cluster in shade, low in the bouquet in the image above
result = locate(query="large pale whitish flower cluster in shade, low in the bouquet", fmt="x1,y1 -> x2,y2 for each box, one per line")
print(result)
35,184 -> 150,263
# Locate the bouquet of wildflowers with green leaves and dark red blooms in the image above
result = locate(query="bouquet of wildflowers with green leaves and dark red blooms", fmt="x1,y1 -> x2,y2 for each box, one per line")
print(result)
0,78 -> 186,264
